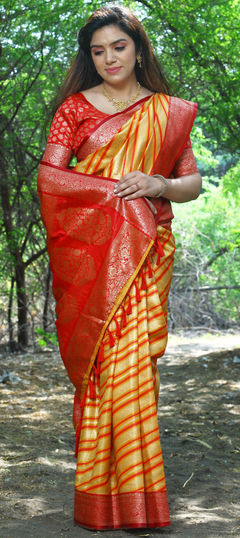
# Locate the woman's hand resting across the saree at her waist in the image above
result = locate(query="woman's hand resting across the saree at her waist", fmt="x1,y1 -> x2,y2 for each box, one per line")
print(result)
114,170 -> 166,200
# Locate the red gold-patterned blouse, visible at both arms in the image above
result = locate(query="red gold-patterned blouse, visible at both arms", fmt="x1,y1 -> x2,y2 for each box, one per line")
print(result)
44,93 -> 198,177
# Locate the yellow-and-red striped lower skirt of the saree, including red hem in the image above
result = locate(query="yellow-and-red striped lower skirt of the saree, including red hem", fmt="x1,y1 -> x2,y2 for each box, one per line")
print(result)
75,227 -> 174,529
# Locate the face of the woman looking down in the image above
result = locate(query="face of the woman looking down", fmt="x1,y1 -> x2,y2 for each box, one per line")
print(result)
90,24 -> 136,85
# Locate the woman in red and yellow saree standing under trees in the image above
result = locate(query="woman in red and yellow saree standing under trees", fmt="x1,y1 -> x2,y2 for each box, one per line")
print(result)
39,6 -> 201,529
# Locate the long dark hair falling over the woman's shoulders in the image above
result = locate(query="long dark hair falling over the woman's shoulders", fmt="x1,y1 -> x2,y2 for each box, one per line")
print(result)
54,4 -> 170,110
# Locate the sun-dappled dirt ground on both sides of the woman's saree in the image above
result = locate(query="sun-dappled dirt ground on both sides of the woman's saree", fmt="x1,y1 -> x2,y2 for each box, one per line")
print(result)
0,332 -> 240,538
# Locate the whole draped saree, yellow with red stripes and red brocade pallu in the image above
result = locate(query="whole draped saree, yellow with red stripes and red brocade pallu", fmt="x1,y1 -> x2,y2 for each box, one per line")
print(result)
39,94 -> 196,529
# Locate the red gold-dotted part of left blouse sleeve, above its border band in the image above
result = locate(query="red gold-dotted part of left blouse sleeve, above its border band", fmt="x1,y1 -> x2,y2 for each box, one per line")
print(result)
47,96 -> 77,150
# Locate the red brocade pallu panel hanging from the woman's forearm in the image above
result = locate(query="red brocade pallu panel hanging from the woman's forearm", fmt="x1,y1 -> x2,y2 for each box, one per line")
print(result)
37,165 -> 156,398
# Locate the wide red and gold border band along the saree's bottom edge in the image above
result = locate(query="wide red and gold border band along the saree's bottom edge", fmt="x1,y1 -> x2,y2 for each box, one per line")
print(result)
74,490 -> 170,530
